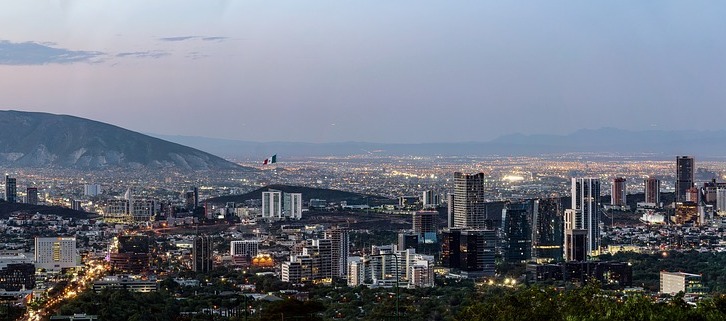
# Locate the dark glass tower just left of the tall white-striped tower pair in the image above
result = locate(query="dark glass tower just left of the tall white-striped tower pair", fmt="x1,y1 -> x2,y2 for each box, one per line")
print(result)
532,198 -> 564,262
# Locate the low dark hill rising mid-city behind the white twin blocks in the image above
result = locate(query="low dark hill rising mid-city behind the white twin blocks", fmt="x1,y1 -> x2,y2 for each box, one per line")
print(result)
206,185 -> 390,205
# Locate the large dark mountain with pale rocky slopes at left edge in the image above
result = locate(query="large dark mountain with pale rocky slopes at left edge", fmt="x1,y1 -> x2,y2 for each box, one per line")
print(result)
0,110 -> 250,170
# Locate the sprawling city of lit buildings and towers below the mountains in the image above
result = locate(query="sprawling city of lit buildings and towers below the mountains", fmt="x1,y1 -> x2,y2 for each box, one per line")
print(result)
0,149 -> 726,320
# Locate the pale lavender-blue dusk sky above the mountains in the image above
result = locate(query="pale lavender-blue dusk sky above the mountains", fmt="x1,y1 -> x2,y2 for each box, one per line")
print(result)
0,0 -> 726,143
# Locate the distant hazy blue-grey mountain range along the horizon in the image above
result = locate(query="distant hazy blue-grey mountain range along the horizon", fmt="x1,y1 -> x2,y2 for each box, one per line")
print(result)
154,128 -> 726,159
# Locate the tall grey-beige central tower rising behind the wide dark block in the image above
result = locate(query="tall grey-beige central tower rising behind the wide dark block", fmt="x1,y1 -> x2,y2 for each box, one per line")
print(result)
453,172 -> 486,228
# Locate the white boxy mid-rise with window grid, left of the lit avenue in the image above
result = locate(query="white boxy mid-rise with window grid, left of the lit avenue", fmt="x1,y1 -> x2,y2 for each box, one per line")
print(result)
35,237 -> 80,271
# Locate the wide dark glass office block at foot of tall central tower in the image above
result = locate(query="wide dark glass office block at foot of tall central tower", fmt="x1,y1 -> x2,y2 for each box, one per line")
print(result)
441,228 -> 496,277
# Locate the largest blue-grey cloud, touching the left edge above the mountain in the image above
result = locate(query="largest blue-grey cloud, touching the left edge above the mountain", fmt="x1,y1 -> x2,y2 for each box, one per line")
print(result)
0,40 -> 105,65
